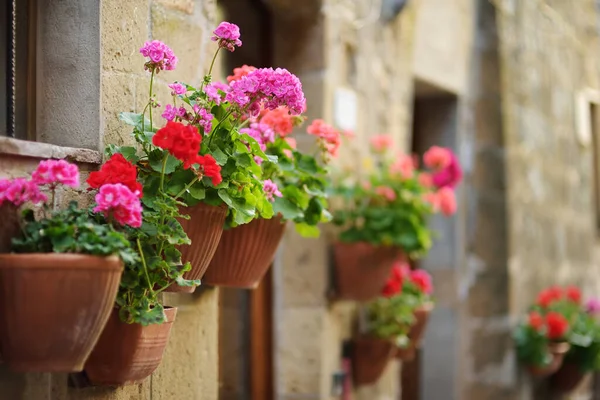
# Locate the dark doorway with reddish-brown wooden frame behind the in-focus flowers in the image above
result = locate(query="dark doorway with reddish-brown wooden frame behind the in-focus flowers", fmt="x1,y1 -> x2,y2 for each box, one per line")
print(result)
219,0 -> 274,400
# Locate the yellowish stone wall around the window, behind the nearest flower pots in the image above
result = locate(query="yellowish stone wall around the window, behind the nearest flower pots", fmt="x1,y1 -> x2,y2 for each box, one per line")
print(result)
0,0 -> 218,400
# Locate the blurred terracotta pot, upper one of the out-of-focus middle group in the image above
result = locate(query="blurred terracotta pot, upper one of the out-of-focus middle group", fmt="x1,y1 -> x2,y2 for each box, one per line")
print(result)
333,242 -> 400,301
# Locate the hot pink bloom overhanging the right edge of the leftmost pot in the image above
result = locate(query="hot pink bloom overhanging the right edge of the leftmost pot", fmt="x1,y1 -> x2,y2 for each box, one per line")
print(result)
94,183 -> 142,228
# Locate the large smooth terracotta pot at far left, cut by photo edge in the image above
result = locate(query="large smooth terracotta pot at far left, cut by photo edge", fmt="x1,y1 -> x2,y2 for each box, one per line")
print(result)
0,253 -> 123,372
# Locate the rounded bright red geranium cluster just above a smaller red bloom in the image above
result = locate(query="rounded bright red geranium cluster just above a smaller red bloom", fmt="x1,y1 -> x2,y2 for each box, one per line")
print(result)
152,121 -> 202,169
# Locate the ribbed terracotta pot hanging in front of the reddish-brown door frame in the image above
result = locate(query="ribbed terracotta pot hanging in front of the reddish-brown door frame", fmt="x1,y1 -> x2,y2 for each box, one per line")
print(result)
203,216 -> 285,289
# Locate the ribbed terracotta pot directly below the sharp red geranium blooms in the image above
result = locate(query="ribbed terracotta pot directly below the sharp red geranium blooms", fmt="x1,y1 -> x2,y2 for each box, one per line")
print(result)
165,203 -> 227,293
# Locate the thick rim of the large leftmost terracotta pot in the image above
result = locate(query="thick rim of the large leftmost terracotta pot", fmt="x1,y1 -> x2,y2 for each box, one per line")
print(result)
0,253 -> 123,270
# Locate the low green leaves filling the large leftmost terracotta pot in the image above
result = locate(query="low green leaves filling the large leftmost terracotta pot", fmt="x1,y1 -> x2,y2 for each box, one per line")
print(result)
12,202 -> 137,263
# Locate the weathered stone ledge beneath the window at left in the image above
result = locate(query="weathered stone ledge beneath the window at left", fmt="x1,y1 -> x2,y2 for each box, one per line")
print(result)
0,137 -> 102,164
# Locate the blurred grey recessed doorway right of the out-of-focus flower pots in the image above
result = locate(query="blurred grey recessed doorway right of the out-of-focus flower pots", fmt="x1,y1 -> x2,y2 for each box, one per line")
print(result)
401,80 -> 462,400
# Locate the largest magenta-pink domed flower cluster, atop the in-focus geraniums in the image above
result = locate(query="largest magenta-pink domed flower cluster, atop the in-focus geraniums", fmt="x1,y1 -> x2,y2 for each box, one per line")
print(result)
225,68 -> 305,116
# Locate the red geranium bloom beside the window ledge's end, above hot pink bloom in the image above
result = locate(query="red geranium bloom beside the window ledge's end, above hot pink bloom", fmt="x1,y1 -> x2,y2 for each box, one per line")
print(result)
87,153 -> 142,197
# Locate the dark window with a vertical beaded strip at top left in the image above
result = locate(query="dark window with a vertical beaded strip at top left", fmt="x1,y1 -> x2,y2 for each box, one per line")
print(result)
0,0 -> 37,140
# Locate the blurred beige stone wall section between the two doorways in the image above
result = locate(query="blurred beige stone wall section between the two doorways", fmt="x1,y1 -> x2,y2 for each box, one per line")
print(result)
273,1 -> 417,400
